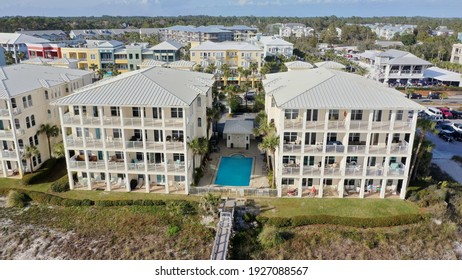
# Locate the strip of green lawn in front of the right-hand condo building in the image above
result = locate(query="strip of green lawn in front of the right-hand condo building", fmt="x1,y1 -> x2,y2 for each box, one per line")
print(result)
256,198 -> 421,218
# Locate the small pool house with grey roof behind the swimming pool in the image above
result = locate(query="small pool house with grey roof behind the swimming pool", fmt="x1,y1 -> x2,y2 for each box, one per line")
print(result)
223,120 -> 253,149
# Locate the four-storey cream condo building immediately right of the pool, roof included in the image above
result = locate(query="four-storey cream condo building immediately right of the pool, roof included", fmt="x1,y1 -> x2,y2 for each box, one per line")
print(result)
263,68 -> 423,198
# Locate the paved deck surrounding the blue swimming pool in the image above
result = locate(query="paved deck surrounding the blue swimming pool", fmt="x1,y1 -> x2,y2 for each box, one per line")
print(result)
198,139 -> 269,188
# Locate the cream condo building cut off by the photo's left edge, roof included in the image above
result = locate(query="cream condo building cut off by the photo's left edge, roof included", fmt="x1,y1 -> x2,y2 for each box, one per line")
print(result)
0,64 -> 93,177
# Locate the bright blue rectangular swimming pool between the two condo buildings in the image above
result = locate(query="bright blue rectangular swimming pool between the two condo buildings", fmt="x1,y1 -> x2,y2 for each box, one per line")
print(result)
215,155 -> 252,187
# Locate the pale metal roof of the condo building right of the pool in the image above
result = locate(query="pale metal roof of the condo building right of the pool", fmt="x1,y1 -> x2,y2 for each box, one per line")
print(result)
263,68 -> 424,109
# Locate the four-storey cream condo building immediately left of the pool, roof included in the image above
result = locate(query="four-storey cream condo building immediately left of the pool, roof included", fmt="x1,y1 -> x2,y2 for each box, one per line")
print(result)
53,67 -> 214,194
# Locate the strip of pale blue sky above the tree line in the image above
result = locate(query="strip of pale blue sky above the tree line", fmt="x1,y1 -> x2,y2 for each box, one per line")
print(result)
0,0 -> 462,17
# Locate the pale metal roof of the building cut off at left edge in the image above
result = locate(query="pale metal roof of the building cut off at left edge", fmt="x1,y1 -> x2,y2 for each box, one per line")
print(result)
0,64 -> 93,99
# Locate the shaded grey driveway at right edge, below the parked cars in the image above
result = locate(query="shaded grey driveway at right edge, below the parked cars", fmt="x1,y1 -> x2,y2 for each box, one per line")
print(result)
426,133 -> 462,184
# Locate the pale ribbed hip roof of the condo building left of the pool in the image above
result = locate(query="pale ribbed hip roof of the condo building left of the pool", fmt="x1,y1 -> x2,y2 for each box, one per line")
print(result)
52,67 -> 215,107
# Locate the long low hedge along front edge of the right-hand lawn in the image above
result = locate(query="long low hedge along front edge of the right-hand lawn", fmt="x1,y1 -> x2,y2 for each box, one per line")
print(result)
257,214 -> 425,228
